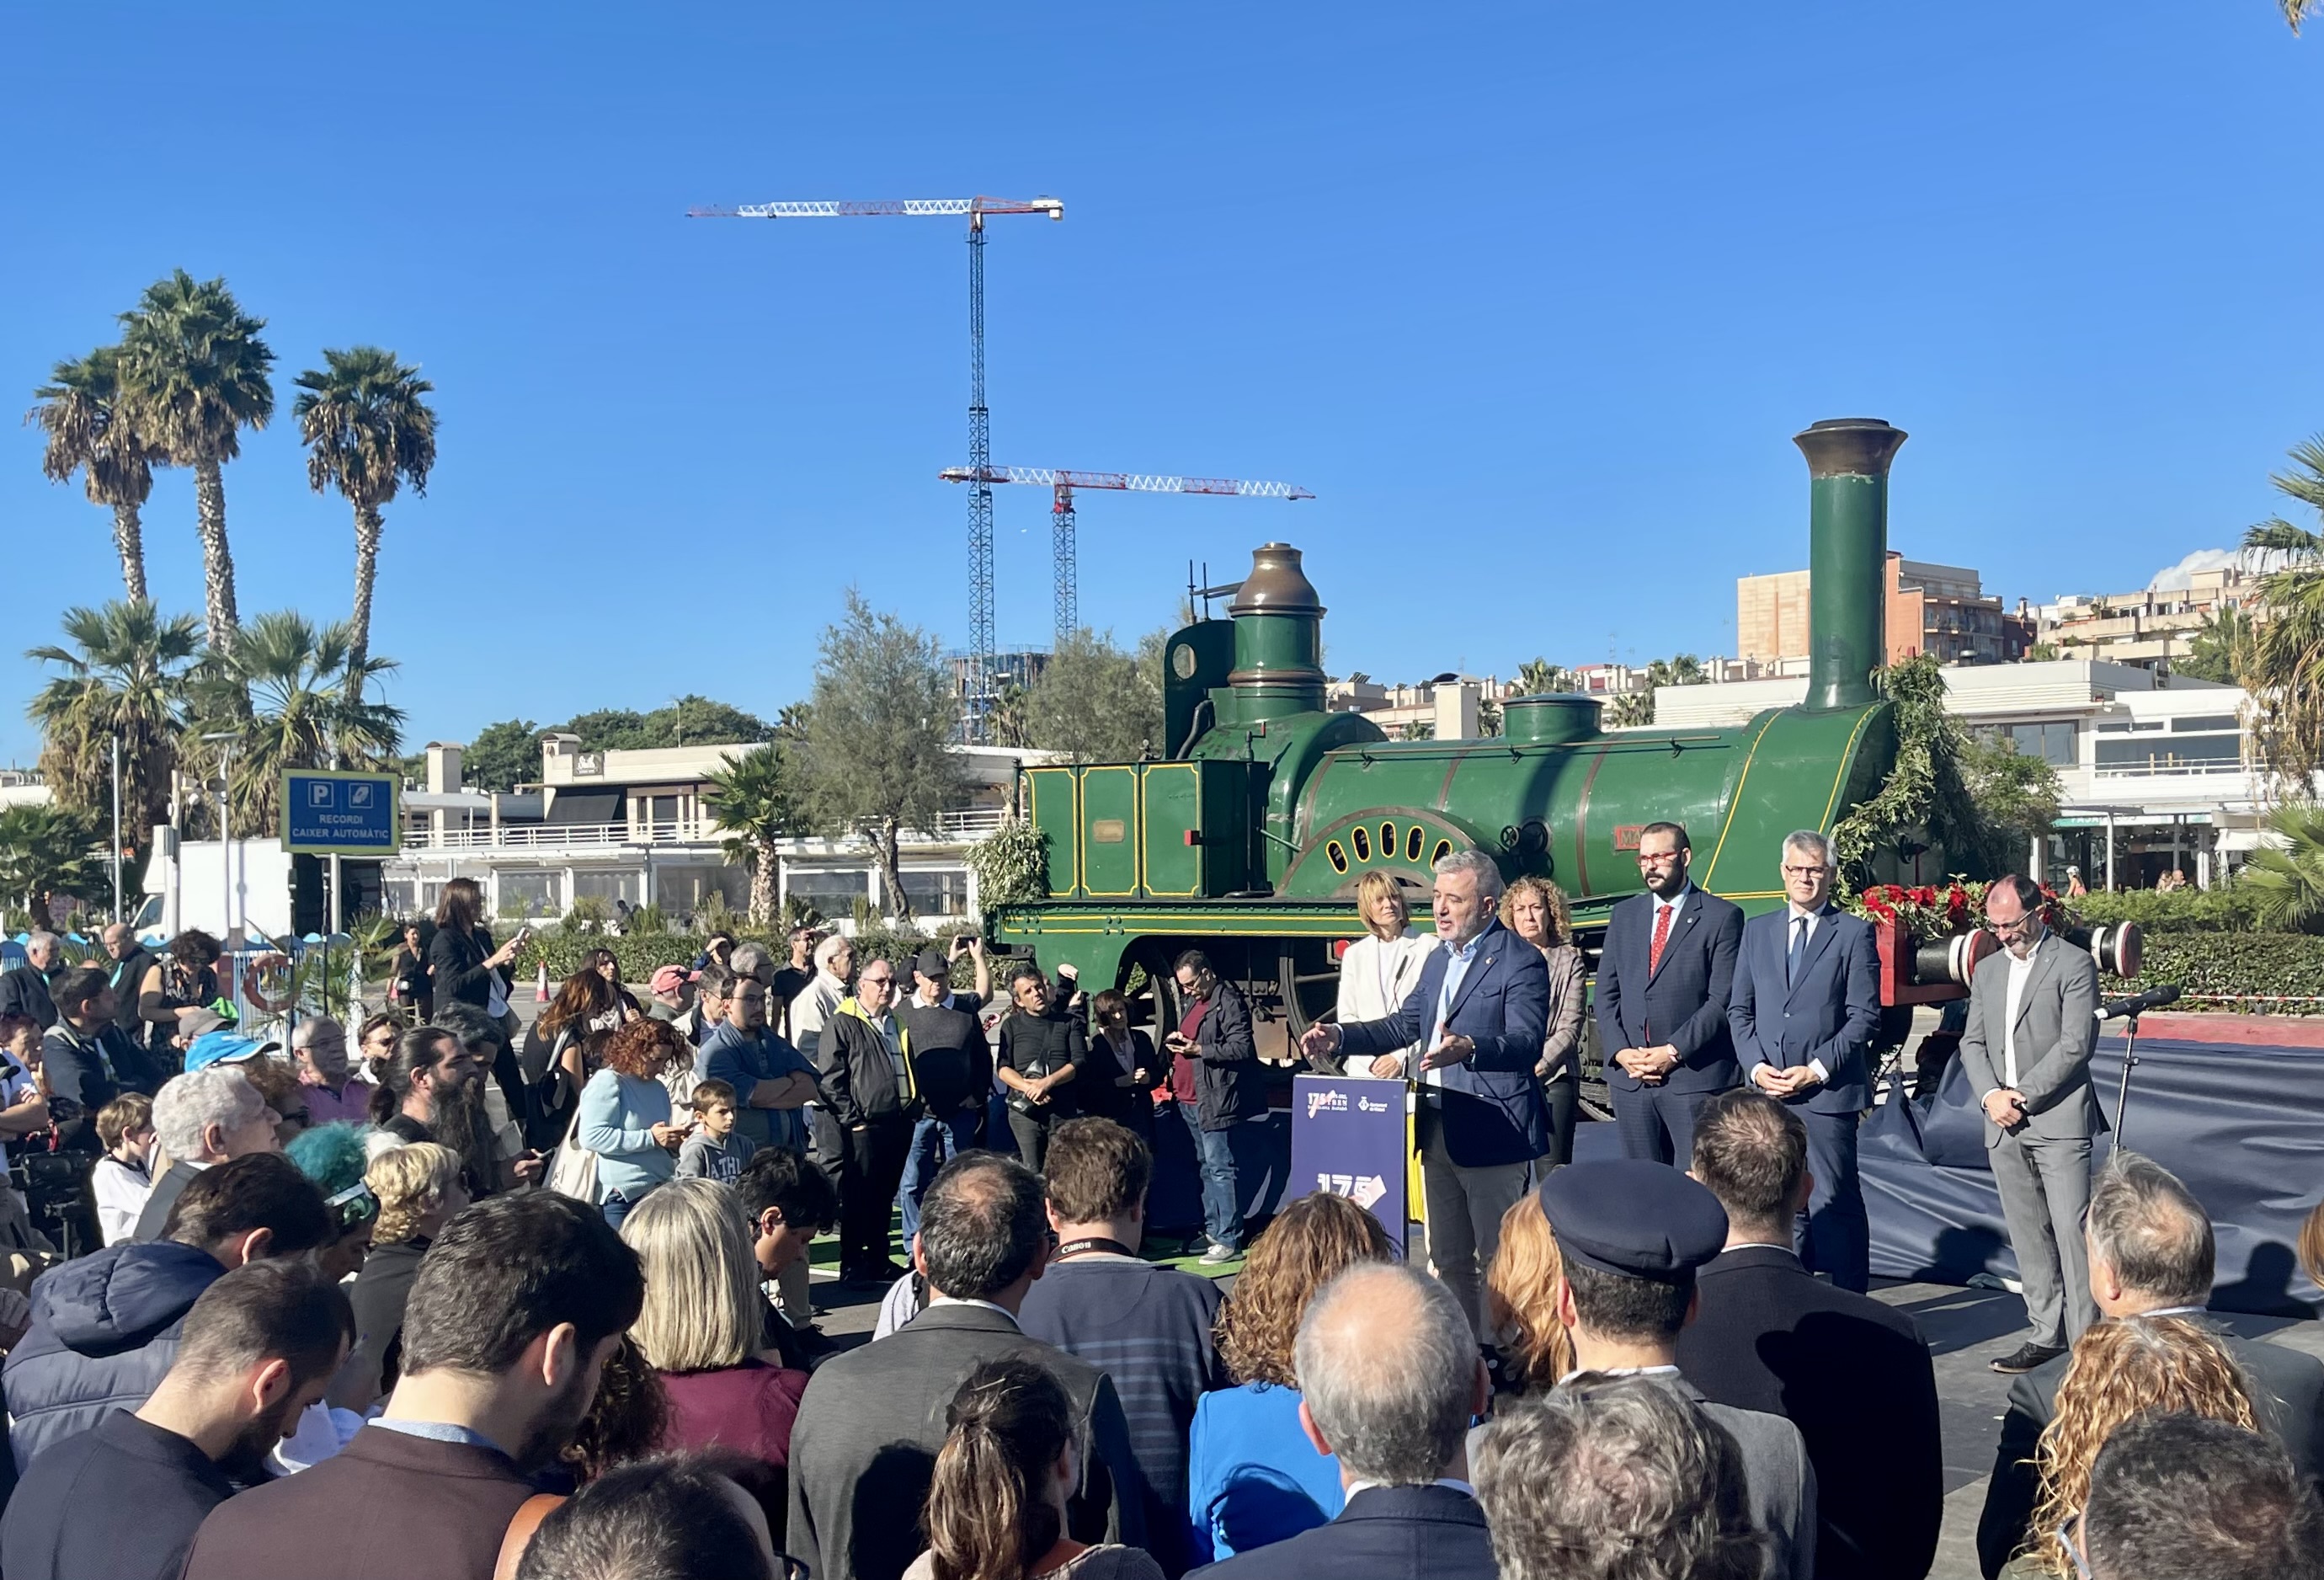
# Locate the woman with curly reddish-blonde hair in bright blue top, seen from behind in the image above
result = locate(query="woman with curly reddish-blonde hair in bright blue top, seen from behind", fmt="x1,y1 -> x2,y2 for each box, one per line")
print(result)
1186,1192 -> 1397,1564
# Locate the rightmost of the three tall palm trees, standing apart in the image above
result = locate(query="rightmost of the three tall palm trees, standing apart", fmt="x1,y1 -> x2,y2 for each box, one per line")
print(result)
290,346 -> 434,670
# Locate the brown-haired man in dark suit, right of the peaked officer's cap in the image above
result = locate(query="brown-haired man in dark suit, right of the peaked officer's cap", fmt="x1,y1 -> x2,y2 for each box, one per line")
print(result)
1678,1090 -> 1945,1580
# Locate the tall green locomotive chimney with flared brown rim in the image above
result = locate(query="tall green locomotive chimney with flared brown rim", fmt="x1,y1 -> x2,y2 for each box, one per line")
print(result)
1792,416 -> 1906,708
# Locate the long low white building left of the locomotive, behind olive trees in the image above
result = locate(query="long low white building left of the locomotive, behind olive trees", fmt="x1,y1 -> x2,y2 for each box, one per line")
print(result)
381,734 -> 1053,930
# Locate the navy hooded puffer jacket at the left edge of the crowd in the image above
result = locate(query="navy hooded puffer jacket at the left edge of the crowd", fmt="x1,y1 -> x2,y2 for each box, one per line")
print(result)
0,1241 -> 226,1471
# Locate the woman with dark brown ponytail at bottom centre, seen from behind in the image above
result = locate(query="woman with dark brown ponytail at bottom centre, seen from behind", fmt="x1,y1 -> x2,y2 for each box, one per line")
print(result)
904,1357 -> 1162,1580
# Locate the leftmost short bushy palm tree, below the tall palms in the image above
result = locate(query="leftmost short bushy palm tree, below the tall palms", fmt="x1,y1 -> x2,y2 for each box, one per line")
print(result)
25,600 -> 202,864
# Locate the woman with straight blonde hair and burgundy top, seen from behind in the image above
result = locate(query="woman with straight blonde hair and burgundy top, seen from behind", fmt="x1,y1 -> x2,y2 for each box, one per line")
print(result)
621,1178 -> 807,1519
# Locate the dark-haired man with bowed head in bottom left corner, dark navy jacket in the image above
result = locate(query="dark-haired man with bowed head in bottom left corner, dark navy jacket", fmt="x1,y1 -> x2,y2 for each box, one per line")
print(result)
0,1259 -> 355,1580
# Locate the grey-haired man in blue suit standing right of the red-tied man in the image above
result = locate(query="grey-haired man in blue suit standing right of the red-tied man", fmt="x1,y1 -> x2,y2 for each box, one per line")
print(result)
1727,830 -> 1880,1294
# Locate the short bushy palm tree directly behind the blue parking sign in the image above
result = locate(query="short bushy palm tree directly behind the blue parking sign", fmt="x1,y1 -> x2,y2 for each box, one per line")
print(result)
195,609 -> 404,839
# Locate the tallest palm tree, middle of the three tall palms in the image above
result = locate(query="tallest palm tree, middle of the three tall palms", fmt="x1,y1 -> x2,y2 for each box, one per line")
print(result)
121,270 -> 275,655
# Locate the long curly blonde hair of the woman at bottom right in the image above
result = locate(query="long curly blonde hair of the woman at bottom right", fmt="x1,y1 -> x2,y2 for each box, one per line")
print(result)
2001,1317 -> 2259,1575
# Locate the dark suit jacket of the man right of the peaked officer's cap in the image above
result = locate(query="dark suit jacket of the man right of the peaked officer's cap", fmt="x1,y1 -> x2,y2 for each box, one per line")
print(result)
1678,1246 -> 1945,1580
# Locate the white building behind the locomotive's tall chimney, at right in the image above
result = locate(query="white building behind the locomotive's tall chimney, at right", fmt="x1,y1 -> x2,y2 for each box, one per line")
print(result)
1655,660 -> 2266,888
